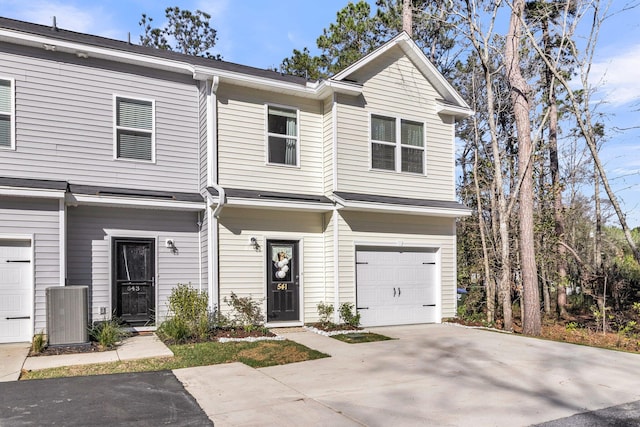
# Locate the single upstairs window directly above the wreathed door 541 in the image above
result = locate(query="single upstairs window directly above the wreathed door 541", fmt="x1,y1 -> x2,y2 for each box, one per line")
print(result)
267,105 -> 298,166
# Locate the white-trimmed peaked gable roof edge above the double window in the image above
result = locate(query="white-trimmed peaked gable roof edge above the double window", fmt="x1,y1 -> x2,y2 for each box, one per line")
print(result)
330,31 -> 473,117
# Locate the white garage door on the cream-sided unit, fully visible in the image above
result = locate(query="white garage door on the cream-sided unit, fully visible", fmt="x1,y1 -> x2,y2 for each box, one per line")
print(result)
356,249 -> 438,326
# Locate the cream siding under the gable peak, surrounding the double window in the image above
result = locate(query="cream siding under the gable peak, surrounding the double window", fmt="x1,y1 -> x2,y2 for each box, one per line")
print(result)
336,48 -> 455,200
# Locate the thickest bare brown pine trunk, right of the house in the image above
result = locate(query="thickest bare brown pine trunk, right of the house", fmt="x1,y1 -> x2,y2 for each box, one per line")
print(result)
505,0 -> 542,335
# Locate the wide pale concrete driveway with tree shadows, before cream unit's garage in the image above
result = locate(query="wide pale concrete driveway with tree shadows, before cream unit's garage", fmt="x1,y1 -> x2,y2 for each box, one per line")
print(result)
174,325 -> 640,426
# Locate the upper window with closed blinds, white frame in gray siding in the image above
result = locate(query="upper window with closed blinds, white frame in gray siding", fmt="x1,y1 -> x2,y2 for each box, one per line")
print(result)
115,97 -> 155,162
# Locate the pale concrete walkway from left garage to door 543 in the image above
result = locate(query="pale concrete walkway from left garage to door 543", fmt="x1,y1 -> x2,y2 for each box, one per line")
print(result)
0,334 -> 173,381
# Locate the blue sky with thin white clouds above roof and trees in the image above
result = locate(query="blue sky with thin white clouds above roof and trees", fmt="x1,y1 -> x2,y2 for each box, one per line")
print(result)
0,0 -> 640,227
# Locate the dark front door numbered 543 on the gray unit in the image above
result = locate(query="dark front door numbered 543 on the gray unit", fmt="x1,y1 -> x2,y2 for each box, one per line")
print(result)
113,238 -> 156,326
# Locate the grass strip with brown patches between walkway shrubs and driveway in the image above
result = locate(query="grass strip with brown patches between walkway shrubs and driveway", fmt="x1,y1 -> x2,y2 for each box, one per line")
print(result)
20,340 -> 329,380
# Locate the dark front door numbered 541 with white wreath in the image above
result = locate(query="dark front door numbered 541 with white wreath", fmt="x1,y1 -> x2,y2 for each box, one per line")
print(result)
267,240 -> 300,322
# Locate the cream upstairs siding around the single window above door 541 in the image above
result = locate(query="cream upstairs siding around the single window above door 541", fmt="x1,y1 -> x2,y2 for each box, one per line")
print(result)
217,85 -> 323,194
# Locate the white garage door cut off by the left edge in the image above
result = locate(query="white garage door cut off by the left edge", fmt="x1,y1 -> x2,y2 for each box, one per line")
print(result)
0,240 -> 32,343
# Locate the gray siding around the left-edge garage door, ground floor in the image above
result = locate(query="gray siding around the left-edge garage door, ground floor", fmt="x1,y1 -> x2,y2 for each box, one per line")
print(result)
0,196 -> 61,332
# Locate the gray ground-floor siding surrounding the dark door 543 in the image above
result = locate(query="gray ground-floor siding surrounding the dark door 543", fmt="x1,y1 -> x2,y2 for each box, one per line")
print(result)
67,207 -> 206,320
